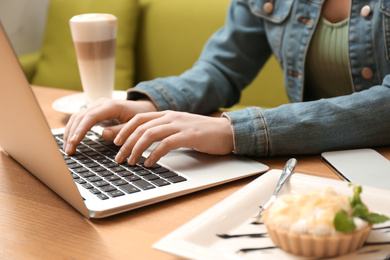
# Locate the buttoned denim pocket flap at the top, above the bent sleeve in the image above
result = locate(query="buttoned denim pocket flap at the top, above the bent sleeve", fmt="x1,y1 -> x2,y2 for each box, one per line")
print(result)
249,0 -> 294,23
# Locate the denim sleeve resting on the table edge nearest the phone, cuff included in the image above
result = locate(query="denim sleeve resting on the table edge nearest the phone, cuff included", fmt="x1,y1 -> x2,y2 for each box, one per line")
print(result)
223,75 -> 390,156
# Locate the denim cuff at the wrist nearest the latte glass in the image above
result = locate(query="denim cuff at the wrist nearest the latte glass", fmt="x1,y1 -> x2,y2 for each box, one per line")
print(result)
127,81 -> 177,111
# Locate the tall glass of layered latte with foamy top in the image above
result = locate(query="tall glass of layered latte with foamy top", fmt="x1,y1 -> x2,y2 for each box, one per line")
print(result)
69,13 -> 117,106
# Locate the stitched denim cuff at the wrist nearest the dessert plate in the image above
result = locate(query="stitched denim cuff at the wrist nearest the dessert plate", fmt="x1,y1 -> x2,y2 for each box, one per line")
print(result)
222,107 -> 269,156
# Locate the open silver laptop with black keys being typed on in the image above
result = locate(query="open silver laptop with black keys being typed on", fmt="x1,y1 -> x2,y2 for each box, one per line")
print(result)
0,23 -> 268,218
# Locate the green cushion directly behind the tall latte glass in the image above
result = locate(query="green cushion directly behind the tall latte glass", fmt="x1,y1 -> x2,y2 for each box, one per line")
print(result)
32,0 -> 138,90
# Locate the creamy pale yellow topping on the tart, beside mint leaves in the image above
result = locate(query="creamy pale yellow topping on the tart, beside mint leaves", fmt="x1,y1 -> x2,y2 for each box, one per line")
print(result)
268,188 -> 368,236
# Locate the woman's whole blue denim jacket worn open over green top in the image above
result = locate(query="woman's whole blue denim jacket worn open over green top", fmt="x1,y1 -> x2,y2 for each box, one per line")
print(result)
129,0 -> 390,156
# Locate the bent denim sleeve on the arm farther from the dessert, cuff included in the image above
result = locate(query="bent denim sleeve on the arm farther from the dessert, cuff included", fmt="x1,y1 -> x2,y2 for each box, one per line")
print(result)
128,0 -> 271,114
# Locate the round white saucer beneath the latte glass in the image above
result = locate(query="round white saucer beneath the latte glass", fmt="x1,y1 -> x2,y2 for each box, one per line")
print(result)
52,90 -> 127,115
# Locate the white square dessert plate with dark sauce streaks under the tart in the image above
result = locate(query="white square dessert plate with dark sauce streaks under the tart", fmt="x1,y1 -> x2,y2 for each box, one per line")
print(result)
153,170 -> 390,260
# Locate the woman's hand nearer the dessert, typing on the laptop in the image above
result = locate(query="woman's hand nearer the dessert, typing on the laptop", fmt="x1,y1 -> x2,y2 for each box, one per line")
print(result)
104,111 -> 233,167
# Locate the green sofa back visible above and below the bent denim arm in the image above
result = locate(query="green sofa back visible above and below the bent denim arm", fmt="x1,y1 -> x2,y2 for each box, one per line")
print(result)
136,0 -> 289,110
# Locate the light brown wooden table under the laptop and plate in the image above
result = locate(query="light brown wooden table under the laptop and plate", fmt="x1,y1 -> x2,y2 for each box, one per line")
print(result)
0,87 -> 390,259
